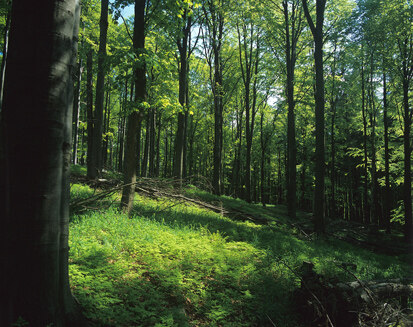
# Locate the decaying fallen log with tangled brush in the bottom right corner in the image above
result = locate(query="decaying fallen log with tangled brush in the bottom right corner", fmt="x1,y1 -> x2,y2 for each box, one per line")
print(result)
294,262 -> 413,327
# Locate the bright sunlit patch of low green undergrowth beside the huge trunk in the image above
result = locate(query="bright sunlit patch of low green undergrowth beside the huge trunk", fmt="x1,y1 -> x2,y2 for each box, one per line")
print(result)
70,210 -> 290,326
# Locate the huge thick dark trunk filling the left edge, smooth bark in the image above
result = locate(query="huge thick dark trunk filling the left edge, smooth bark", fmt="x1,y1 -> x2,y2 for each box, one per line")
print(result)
0,0 -> 80,327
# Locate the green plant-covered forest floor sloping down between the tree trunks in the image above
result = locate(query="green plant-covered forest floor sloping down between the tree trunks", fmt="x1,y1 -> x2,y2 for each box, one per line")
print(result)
69,166 -> 412,327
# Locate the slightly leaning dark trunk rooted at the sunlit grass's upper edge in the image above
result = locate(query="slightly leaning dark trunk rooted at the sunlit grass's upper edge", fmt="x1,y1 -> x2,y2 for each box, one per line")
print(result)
121,0 -> 146,213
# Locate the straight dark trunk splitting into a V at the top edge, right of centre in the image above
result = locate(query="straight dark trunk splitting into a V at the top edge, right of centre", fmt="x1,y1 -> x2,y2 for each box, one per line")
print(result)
302,0 -> 327,234
